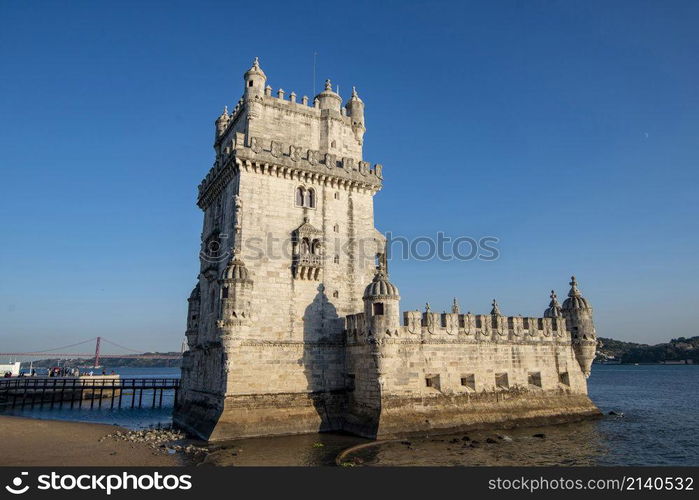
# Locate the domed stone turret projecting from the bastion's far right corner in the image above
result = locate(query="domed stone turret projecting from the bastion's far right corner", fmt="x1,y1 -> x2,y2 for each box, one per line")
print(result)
561,276 -> 597,377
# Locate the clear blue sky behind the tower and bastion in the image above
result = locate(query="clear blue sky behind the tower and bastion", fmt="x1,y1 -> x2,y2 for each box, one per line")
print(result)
0,0 -> 699,352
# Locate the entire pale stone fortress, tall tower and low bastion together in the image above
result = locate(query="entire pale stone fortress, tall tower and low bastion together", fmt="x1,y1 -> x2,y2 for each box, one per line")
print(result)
175,60 -> 599,440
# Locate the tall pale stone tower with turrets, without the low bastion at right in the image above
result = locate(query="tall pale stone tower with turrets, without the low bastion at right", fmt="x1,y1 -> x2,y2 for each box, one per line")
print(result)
175,59 -> 382,439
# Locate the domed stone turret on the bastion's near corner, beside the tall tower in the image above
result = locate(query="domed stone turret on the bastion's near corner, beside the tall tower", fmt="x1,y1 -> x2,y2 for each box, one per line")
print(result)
363,263 -> 400,338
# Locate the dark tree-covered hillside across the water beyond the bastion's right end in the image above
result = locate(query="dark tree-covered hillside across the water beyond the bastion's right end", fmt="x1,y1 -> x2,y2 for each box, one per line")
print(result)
596,337 -> 699,364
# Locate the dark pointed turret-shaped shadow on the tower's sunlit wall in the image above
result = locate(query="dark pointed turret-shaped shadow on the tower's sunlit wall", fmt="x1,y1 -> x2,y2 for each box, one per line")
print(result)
300,284 -> 345,432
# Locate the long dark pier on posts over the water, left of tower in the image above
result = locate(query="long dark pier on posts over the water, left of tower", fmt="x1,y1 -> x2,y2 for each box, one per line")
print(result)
0,376 -> 180,409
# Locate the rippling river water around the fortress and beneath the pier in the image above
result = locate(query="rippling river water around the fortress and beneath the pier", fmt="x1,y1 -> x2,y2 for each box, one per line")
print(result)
1,365 -> 699,466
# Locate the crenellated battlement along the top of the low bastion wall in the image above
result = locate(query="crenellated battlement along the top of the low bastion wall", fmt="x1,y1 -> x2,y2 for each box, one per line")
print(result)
345,310 -> 571,344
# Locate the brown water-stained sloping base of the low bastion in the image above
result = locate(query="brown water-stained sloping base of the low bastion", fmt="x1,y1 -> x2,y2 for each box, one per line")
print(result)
355,392 -> 602,439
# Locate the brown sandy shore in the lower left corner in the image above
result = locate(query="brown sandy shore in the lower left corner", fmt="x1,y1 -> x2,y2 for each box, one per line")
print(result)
0,416 -> 183,466
